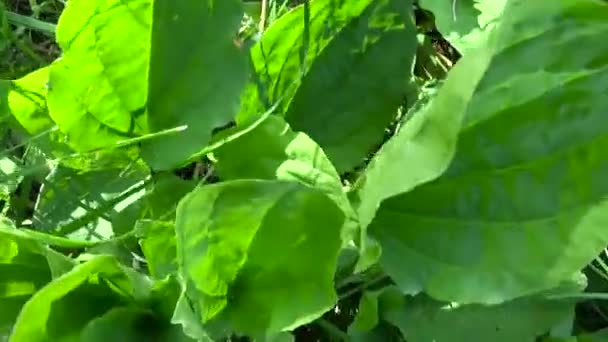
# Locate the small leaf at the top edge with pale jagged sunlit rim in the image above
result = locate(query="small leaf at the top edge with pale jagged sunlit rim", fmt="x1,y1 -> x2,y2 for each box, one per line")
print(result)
419,0 -> 507,55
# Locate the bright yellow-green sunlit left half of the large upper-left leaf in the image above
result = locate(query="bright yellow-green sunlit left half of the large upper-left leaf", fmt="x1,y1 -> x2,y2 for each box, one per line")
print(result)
47,0 -> 152,151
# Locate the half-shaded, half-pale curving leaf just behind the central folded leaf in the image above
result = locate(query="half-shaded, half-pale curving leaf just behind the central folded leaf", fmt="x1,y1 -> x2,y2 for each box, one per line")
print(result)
214,115 -> 357,242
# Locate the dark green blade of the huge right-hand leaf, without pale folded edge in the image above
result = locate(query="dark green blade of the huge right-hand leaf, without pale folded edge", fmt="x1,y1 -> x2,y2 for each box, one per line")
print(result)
369,0 -> 608,304
